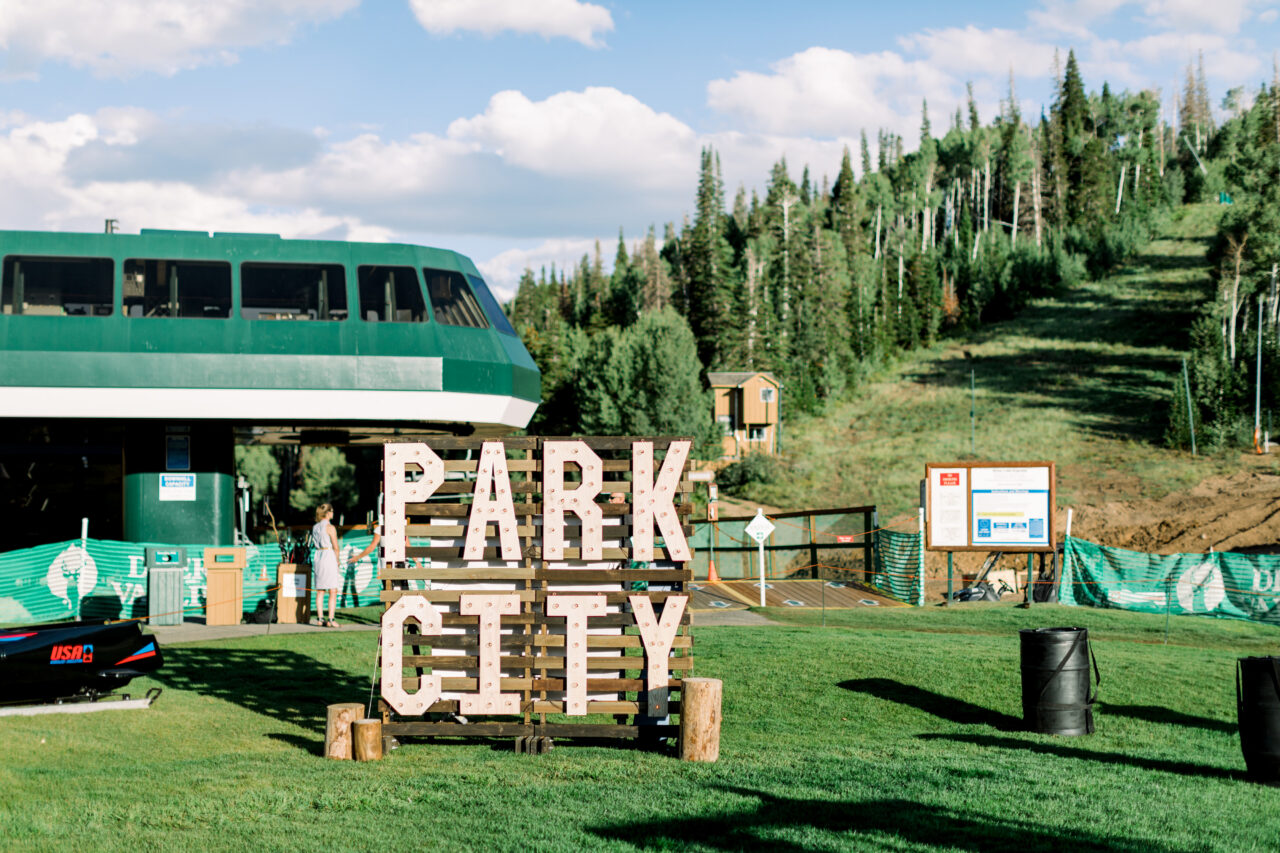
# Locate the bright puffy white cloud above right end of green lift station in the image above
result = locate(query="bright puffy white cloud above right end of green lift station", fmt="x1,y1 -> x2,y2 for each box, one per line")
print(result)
448,87 -> 698,186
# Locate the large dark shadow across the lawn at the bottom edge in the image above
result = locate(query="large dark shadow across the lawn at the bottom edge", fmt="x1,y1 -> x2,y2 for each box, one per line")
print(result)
588,788 -> 1171,853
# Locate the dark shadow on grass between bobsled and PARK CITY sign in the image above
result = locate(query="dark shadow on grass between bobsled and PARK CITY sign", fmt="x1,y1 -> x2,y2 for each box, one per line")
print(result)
152,647 -> 369,733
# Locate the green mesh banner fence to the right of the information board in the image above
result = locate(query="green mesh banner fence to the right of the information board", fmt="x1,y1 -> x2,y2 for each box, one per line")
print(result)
1059,537 -> 1280,625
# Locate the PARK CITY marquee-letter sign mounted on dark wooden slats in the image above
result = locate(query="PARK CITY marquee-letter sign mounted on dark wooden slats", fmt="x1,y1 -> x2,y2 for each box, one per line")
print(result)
380,437 -> 694,752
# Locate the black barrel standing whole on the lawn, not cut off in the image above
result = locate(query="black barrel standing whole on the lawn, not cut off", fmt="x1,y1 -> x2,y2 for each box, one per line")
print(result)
1019,628 -> 1101,735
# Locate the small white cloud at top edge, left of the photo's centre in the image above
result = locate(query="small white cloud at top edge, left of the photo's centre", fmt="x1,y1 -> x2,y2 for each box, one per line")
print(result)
410,0 -> 613,47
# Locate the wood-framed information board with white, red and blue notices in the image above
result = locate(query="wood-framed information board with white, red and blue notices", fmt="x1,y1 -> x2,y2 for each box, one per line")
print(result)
924,462 -> 1055,552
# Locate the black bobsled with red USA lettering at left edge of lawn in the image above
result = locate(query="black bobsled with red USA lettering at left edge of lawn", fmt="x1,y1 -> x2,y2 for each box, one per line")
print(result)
0,614 -> 163,704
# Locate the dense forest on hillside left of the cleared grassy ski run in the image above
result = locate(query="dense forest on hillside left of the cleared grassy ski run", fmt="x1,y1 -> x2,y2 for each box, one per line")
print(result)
508,53 -> 1213,455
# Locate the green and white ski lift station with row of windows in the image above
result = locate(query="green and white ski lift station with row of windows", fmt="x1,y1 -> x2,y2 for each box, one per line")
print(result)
0,231 -> 540,548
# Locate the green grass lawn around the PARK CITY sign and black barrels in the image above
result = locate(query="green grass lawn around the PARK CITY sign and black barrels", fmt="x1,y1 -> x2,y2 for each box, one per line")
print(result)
0,606 -> 1280,850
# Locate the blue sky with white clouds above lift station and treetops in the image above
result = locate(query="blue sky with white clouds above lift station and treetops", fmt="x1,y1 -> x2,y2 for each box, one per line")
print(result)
0,0 -> 1280,297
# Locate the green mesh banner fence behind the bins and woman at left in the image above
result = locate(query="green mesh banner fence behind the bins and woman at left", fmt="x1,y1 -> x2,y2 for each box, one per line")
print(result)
0,535 -> 378,625
